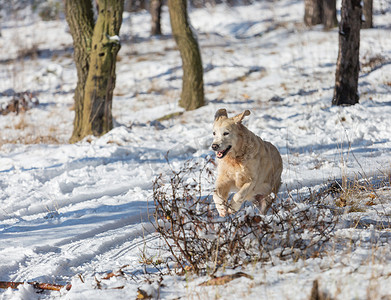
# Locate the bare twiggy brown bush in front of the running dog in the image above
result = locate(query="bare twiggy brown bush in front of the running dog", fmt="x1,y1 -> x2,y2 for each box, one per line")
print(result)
153,159 -> 337,274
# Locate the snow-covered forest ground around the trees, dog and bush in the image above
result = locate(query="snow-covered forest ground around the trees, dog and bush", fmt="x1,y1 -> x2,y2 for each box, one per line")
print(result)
0,0 -> 391,299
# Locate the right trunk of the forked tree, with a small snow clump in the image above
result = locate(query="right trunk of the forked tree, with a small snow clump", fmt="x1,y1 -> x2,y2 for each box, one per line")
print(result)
82,0 -> 123,136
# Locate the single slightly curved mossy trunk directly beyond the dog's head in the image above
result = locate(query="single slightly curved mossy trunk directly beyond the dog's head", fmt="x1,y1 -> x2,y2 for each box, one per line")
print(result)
168,0 -> 204,110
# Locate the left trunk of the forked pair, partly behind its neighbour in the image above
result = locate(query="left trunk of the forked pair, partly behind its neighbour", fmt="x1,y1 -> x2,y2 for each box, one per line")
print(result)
65,0 -> 94,142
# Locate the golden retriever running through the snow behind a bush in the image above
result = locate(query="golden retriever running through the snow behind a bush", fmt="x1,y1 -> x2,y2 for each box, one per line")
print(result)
212,109 -> 282,217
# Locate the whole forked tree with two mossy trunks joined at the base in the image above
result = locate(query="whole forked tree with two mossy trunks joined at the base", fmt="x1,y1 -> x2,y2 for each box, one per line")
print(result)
65,0 -> 123,142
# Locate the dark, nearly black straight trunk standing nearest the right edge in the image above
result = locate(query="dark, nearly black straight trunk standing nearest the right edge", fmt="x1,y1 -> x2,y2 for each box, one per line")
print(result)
332,0 -> 361,105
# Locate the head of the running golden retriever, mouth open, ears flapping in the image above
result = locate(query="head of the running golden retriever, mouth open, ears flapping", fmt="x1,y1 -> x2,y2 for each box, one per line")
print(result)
212,108 -> 250,159
